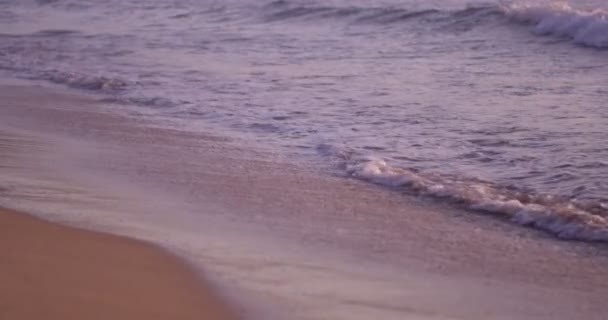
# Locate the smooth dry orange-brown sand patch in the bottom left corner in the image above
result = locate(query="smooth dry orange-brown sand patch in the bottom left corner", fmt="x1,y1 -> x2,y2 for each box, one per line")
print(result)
0,209 -> 234,320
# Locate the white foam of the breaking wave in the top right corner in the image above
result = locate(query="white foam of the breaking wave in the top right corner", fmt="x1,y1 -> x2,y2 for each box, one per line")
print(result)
501,2 -> 608,48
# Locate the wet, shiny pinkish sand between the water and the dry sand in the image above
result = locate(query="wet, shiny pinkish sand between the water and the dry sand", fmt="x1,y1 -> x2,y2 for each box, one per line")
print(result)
0,85 -> 608,319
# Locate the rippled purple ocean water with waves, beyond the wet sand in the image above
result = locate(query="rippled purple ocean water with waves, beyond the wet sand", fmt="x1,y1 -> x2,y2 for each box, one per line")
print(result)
0,0 -> 608,241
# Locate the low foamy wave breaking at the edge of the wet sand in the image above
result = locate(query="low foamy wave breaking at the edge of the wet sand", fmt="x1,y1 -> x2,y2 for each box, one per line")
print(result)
318,145 -> 608,242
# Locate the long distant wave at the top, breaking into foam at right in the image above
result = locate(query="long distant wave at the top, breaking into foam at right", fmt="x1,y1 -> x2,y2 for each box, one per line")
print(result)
263,1 -> 608,48
